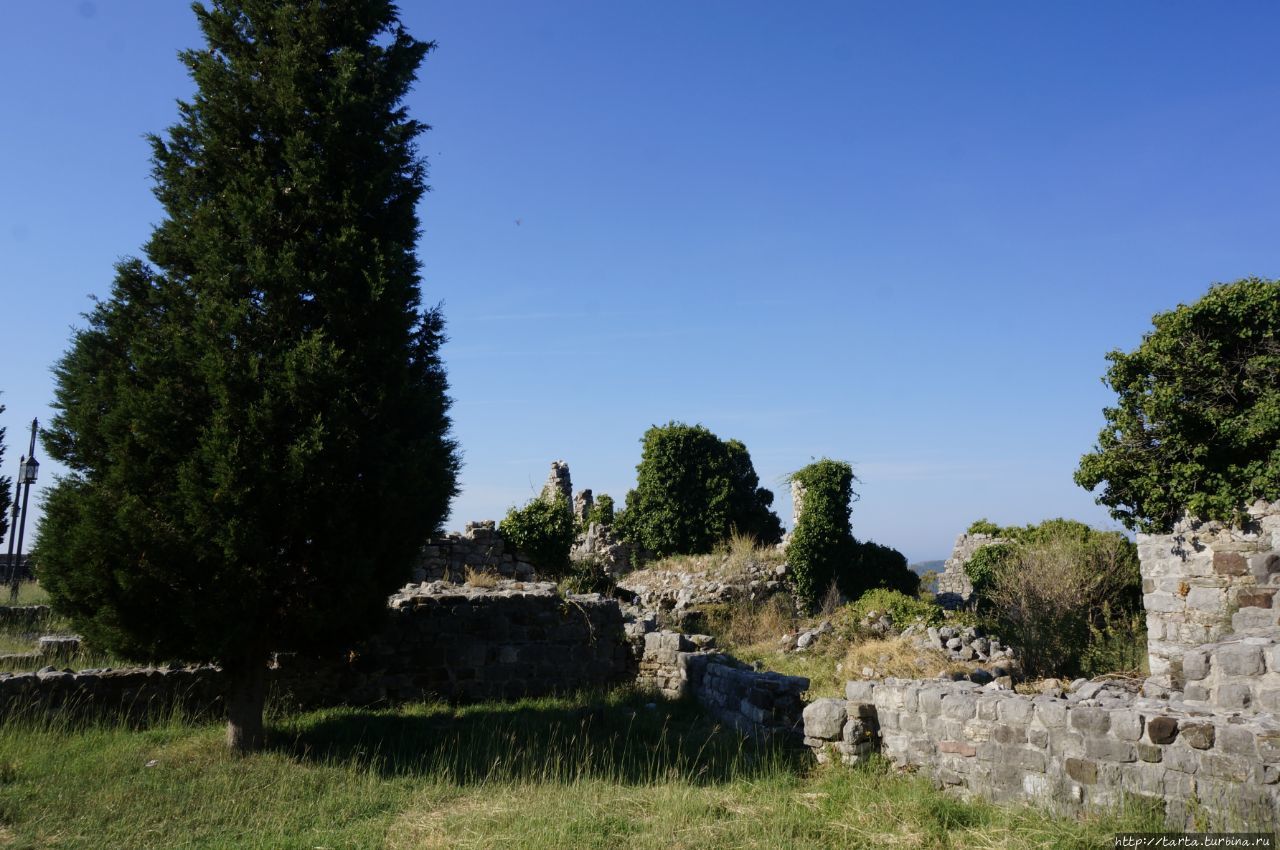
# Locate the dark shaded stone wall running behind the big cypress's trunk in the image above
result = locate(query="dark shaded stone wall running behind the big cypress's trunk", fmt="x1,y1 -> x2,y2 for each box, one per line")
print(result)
0,581 -> 635,718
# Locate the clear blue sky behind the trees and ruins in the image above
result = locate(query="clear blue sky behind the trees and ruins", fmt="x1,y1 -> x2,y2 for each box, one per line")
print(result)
0,0 -> 1280,561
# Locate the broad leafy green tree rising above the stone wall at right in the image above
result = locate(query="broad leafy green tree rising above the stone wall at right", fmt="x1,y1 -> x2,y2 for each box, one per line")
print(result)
1075,278 -> 1280,533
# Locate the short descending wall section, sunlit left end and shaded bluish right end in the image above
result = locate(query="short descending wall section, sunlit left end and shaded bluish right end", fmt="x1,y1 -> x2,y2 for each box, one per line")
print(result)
636,631 -> 809,742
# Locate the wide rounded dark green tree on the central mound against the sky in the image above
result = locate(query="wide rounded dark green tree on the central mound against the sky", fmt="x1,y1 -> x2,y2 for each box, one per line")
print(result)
616,422 -> 782,557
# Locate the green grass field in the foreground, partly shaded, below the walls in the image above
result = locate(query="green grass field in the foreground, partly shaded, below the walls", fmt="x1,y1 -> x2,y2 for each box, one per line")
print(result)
0,691 -> 1158,850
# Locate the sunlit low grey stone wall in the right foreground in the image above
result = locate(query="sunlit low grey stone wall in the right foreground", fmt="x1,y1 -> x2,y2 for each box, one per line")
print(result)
805,680 -> 1280,830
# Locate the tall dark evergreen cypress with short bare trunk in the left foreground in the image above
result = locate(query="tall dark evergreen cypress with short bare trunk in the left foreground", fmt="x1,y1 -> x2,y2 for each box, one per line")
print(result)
38,0 -> 458,750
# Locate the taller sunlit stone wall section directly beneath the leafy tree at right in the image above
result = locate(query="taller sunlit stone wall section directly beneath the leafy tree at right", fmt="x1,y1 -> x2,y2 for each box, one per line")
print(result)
1138,502 -> 1280,690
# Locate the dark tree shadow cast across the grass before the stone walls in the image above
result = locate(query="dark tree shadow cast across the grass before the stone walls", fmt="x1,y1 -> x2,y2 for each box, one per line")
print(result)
271,695 -> 808,785
